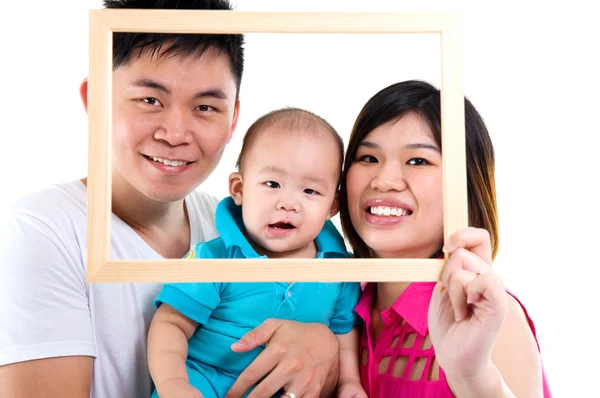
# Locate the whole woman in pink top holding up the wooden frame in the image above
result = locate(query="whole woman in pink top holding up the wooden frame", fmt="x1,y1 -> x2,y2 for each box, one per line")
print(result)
340,81 -> 550,398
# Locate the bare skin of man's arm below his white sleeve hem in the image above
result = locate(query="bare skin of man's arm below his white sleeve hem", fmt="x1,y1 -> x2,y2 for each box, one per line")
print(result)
0,356 -> 94,398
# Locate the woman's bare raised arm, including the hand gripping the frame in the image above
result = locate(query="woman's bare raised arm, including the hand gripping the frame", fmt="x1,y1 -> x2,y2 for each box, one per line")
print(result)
429,228 -> 543,398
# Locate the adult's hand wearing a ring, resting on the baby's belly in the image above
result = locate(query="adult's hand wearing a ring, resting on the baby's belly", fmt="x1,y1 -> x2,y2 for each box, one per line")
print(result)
226,319 -> 339,398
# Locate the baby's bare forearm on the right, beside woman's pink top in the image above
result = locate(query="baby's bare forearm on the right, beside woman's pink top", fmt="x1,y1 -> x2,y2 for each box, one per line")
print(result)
336,327 -> 367,398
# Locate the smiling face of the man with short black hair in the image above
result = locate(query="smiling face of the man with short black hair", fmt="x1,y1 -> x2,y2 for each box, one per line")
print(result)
112,50 -> 239,202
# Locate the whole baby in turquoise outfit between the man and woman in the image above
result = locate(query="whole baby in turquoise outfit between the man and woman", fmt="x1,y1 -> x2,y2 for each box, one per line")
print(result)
148,108 -> 364,397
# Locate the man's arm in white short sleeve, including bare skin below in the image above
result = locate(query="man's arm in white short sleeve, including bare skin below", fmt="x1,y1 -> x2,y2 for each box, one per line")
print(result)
0,212 -> 95,398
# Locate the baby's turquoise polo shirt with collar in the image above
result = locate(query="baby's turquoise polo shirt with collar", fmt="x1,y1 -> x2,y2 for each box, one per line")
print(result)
155,197 -> 361,381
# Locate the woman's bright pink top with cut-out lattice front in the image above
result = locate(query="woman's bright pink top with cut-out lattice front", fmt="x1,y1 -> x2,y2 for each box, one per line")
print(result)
355,282 -> 552,398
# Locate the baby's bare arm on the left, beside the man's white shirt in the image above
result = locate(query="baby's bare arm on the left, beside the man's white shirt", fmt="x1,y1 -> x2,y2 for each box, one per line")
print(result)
148,304 -> 202,397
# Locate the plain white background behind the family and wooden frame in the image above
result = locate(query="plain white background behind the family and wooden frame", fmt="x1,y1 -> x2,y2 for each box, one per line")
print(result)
0,0 -> 600,397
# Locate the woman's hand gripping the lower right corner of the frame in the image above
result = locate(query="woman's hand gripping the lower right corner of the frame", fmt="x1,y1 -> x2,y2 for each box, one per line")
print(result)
429,228 -> 507,384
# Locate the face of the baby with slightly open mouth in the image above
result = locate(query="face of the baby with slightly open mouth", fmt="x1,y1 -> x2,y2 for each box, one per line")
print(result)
242,127 -> 340,257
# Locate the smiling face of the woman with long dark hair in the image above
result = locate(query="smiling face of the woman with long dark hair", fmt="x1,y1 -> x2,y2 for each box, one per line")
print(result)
346,112 -> 443,258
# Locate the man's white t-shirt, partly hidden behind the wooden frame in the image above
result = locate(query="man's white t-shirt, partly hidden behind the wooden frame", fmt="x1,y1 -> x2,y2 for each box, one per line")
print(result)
0,181 -> 218,398
